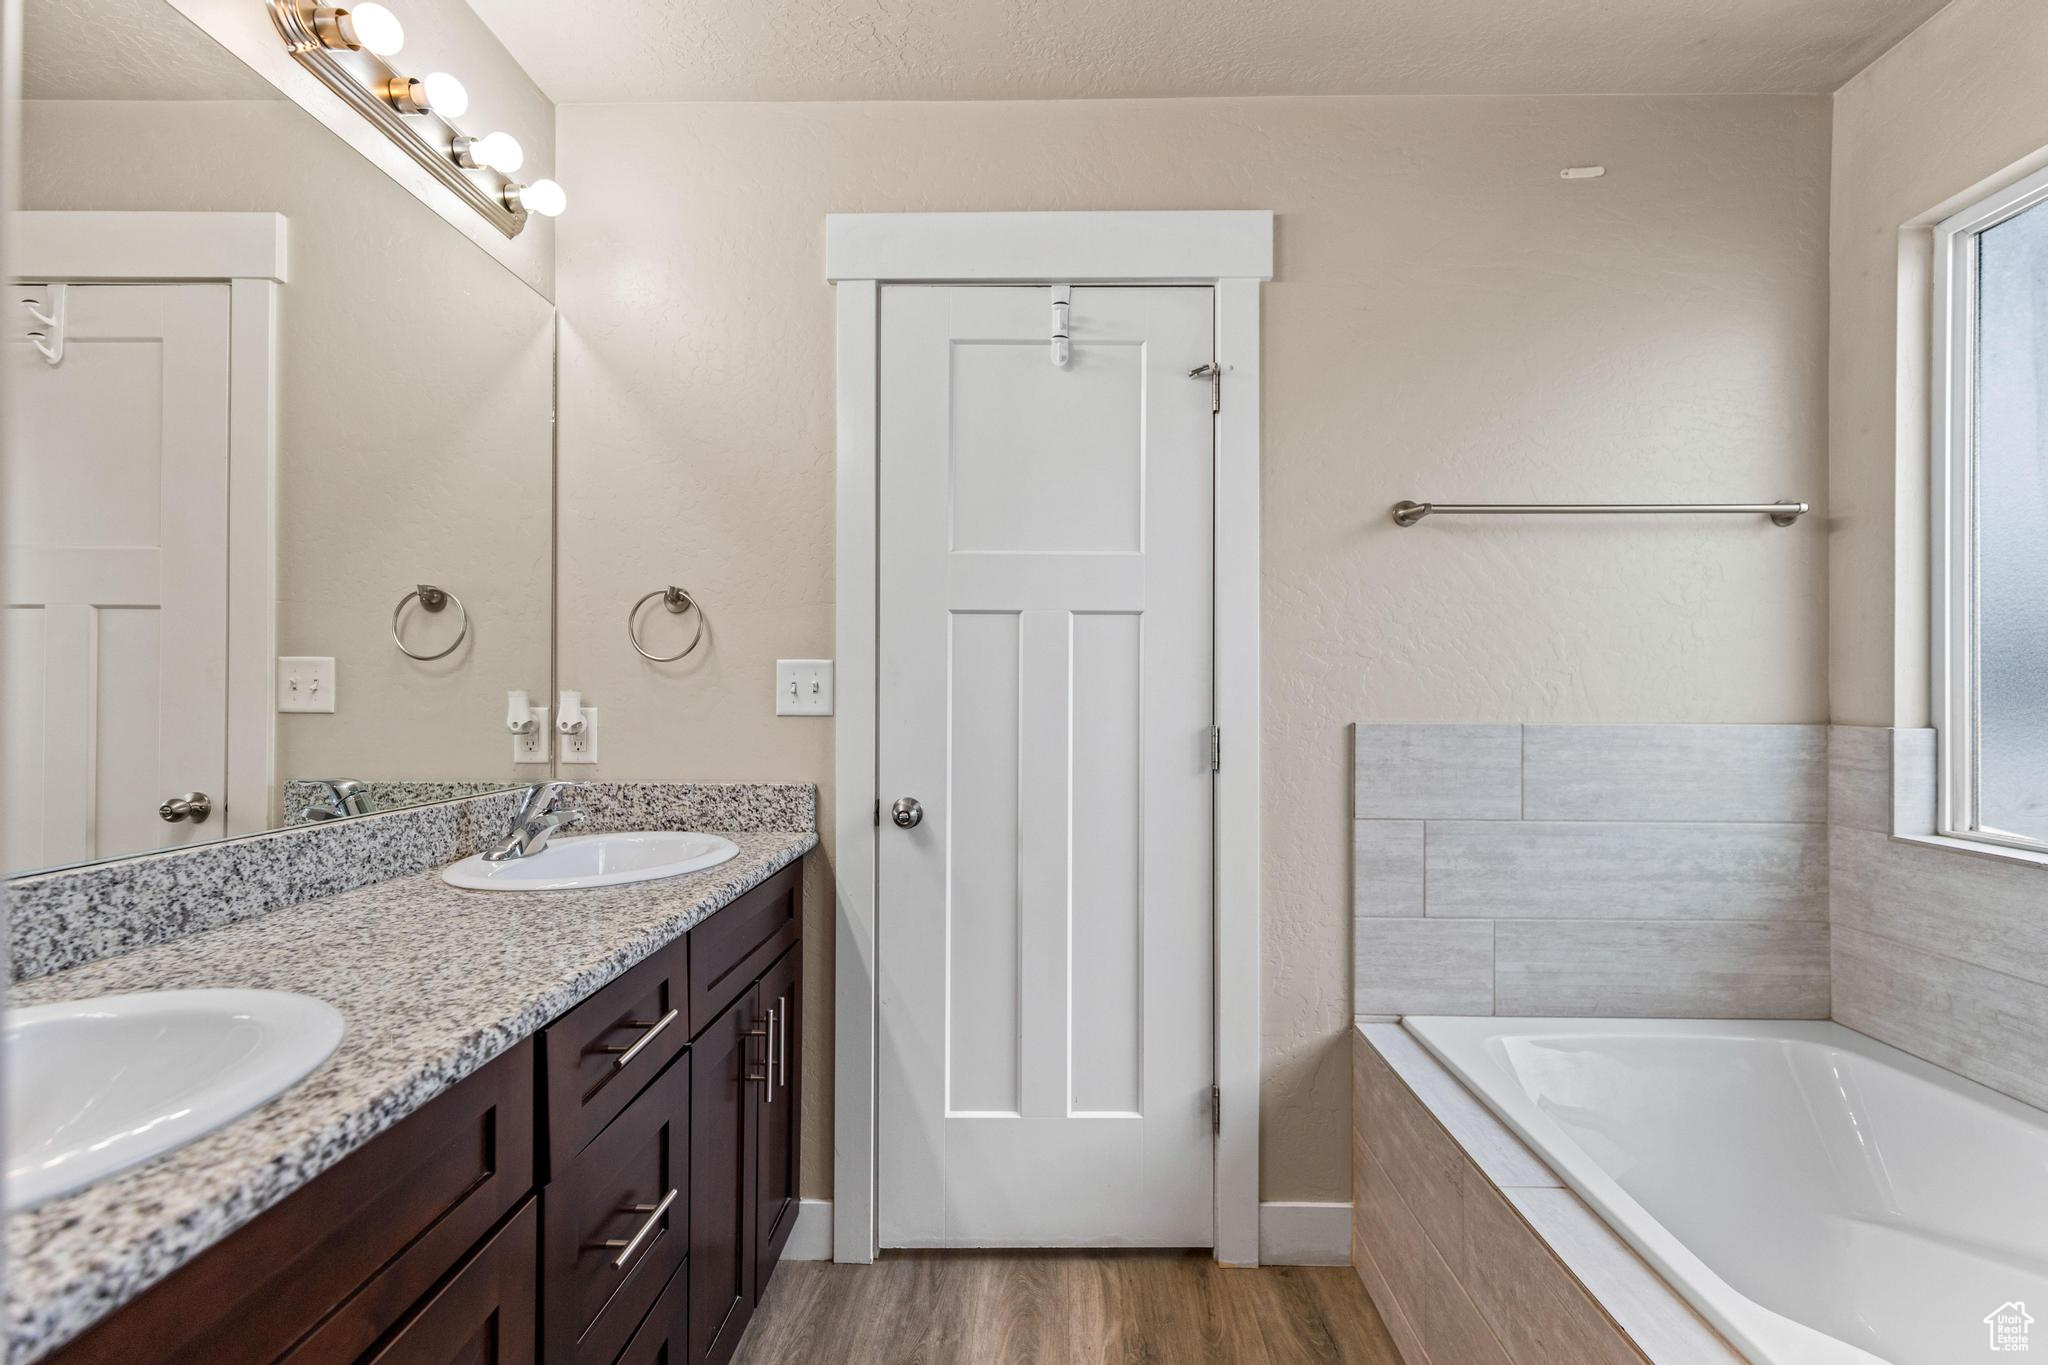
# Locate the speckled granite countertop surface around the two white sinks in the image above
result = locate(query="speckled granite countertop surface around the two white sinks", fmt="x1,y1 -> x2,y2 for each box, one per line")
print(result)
6,831 -> 817,1365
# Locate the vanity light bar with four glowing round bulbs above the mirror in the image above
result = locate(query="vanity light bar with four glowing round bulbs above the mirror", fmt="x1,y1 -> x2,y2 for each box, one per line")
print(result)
264,0 -> 567,237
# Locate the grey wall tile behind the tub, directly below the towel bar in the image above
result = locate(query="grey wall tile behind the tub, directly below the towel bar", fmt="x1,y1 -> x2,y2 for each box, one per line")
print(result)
1352,724 -> 1829,1019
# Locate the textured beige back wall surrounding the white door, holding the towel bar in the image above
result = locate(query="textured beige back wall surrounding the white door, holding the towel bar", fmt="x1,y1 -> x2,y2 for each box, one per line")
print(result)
557,96 -> 1829,1199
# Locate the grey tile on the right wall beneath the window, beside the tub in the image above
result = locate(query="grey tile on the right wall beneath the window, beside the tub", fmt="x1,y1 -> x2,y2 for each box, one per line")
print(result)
1829,726 -> 2048,1107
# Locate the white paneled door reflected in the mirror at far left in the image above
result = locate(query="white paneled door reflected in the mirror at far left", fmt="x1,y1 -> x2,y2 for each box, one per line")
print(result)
0,284 -> 227,872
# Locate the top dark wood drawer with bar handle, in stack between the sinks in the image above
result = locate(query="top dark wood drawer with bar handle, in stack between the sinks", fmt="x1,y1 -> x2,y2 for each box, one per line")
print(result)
541,937 -> 711,1179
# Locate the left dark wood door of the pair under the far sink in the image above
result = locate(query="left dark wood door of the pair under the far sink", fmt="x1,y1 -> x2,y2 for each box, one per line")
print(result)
690,990 -> 768,1365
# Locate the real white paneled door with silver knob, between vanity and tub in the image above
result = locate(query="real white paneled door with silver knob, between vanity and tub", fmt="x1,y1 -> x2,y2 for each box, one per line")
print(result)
877,287 -> 1214,1246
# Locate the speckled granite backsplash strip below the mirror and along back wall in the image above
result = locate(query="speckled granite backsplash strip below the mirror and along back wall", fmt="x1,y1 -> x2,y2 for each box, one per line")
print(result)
8,782 -> 817,980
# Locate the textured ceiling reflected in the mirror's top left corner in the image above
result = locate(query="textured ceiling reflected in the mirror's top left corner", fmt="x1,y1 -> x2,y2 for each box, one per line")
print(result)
20,0 -> 283,100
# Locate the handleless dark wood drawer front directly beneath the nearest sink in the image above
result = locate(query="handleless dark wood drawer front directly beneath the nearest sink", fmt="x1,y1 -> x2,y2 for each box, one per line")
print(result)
53,1042 -> 535,1365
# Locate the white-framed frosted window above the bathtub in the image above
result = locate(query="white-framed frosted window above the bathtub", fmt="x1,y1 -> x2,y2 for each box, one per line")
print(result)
1933,174 -> 2048,849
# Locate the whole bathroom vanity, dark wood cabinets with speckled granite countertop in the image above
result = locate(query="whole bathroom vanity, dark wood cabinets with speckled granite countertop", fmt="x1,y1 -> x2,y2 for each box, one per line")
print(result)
8,794 -> 815,1365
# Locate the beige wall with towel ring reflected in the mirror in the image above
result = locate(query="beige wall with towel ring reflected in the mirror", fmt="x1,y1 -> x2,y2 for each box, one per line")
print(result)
20,100 -> 555,818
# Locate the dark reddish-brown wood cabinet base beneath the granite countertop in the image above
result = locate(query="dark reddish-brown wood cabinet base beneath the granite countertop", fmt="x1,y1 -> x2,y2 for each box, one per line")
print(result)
51,864 -> 803,1365
